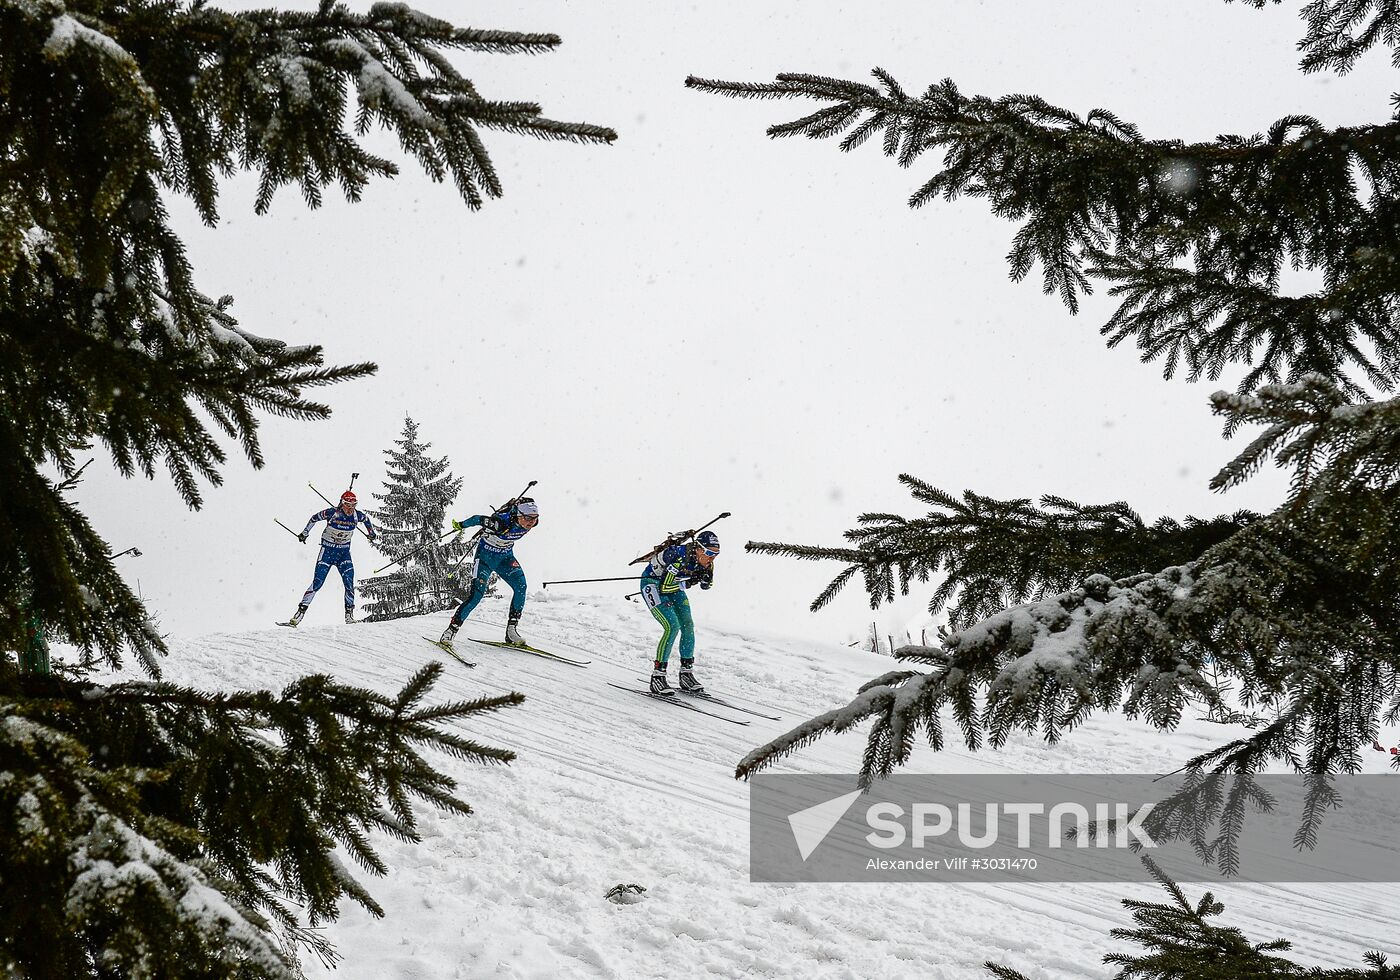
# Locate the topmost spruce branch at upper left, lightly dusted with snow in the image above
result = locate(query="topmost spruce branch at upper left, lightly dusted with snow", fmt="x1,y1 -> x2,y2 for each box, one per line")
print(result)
175,4 -> 616,210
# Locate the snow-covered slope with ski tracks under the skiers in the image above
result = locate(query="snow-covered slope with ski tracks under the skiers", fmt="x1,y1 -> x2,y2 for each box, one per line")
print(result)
95,592 -> 1400,980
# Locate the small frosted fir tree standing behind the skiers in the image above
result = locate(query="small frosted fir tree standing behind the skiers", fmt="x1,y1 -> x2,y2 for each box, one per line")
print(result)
360,416 -> 469,619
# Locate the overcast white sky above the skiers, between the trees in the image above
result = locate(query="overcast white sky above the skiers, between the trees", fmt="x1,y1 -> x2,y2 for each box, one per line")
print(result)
78,0 -> 1394,657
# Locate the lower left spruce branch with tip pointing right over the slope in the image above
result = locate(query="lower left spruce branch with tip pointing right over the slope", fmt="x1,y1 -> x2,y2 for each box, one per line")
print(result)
24,664 -> 524,925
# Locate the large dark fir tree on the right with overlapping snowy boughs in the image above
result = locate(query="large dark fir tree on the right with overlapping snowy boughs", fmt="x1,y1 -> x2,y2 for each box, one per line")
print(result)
687,0 -> 1400,935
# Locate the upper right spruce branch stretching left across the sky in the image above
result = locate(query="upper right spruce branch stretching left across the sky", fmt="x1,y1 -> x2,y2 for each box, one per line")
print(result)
686,69 -> 1400,382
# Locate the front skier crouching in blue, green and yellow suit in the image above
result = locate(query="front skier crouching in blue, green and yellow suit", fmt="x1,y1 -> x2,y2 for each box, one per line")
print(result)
641,531 -> 720,694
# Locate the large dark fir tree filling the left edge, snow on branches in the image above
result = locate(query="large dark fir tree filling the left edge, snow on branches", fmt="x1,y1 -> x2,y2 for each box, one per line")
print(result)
0,0 -> 615,980
